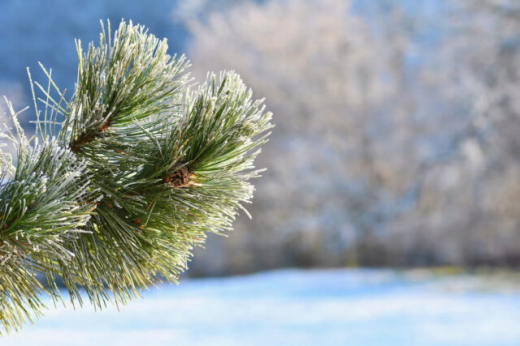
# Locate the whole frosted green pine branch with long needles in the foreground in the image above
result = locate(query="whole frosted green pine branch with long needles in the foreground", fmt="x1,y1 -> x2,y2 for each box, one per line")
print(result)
0,18 -> 273,331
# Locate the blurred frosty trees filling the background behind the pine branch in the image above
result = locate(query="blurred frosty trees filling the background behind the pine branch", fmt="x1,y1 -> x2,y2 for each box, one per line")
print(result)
0,0 -> 520,275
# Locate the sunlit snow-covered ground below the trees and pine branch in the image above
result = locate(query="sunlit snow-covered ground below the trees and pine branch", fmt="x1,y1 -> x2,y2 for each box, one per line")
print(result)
0,270 -> 520,346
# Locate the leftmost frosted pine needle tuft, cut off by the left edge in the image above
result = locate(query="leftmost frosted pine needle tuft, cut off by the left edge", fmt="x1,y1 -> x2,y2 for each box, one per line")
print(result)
0,103 -> 93,330
